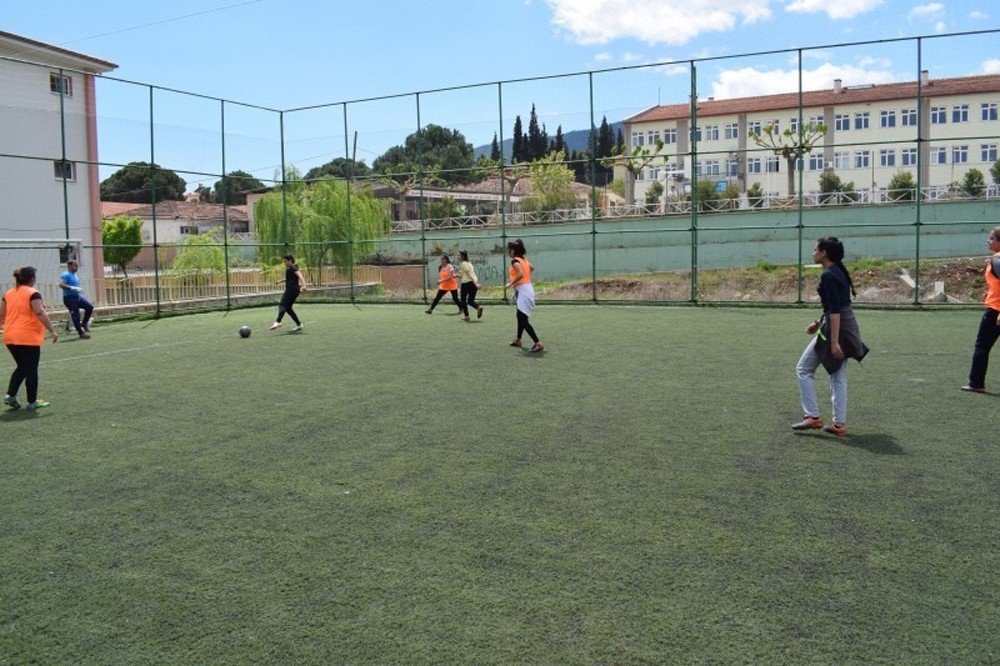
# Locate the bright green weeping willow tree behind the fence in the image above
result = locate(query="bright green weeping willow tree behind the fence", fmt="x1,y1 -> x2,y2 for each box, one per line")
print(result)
254,177 -> 389,272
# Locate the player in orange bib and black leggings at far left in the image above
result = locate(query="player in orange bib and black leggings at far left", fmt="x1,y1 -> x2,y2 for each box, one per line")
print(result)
0,266 -> 59,410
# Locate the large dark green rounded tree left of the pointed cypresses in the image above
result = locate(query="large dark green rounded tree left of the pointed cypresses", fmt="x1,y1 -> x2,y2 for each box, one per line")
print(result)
372,124 -> 479,185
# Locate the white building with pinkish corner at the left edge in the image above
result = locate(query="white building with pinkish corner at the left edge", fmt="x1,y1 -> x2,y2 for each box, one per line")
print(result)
0,32 -> 117,294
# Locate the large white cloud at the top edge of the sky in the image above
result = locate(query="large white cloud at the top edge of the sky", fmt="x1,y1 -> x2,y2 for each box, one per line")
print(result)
546,0 -> 772,45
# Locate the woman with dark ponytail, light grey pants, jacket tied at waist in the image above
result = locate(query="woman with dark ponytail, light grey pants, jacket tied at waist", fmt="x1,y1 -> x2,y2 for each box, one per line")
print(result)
792,236 -> 868,437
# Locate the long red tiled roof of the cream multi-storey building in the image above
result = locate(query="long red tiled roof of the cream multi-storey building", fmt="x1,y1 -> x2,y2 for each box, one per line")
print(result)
624,74 -> 1000,124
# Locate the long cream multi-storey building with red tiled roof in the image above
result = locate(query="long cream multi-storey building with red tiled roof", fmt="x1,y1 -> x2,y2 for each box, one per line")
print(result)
615,72 -> 1000,202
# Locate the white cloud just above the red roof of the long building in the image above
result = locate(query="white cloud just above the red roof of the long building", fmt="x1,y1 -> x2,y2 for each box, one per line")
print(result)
712,63 -> 896,99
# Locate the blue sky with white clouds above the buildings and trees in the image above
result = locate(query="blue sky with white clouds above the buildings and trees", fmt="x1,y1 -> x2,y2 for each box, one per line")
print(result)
0,0 -> 1000,189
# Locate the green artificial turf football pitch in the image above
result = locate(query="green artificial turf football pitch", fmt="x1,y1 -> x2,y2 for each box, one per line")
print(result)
0,303 -> 1000,664
